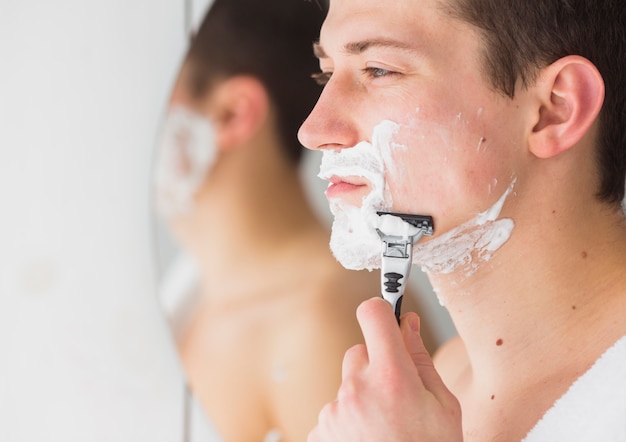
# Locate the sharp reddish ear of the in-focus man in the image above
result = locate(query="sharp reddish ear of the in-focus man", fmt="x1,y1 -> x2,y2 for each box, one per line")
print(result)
529,55 -> 604,158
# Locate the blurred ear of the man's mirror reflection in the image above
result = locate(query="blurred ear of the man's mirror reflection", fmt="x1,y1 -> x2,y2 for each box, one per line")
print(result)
201,75 -> 269,150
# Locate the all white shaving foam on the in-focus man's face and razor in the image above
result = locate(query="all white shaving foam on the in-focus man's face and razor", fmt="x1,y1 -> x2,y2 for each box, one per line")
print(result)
318,115 -> 515,277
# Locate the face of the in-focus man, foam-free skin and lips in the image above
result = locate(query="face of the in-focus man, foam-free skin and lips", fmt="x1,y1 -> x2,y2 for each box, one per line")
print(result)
299,0 -> 526,272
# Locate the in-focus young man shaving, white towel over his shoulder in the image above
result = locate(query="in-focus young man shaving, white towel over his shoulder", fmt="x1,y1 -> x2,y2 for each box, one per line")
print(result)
300,0 -> 626,442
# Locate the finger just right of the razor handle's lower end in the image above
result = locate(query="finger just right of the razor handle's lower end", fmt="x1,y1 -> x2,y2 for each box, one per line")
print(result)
400,312 -> 450,400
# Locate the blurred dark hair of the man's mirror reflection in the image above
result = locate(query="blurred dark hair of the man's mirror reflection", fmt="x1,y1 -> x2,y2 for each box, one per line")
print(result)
186,0 -> 327,163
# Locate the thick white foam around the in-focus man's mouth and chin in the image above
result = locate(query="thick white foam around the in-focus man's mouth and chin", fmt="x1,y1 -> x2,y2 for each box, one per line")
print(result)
318,121 -> 403,270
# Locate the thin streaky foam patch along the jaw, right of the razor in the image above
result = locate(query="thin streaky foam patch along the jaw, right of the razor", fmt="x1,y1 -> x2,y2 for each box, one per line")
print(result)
413,181 -> 515,277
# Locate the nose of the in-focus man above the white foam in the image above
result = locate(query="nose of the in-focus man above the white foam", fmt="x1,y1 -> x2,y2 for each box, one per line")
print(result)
298,75 -> 361,150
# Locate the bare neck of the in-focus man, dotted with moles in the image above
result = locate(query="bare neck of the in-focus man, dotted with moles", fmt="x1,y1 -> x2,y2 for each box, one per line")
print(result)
429,199 -> 626,384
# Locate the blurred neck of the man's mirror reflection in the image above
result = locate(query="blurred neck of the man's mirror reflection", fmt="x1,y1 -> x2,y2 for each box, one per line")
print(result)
175,143 -> 328,294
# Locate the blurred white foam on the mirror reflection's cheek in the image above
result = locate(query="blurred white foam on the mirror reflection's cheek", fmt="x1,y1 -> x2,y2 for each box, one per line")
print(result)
155,106 -> 217,217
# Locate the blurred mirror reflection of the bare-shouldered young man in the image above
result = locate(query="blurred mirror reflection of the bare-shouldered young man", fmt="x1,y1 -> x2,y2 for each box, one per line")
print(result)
157,0 -> 428,441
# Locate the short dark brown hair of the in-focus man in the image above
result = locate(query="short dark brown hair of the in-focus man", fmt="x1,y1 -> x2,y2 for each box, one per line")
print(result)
444,0 -> 626,203
